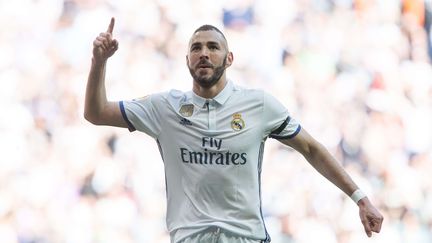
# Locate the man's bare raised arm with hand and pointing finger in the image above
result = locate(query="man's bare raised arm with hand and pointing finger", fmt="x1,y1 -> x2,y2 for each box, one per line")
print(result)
84,18 -> 127,127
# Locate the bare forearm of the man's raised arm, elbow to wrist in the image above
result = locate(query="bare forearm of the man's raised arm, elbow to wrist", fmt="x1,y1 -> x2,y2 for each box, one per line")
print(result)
84,58 -> 108,123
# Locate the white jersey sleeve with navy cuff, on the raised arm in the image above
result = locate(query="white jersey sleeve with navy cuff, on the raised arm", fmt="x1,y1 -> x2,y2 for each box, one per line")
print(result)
119,94 -> 161,138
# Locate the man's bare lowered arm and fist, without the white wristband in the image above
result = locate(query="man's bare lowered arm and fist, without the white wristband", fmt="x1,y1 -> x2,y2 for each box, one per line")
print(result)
279,129 -> 383,237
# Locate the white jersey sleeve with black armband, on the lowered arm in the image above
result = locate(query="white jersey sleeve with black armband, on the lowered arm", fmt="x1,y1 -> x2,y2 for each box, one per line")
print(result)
264,92 -> 301,139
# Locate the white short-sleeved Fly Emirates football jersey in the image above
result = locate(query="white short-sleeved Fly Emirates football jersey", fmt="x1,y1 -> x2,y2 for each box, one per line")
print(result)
119,81 -> 301,242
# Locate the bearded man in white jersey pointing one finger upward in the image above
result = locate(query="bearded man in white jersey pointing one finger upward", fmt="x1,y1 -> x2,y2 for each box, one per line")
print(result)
84,19 -> 383,243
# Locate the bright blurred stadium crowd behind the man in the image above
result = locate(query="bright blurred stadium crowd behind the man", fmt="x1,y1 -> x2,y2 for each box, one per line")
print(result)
0,0 -> 432,243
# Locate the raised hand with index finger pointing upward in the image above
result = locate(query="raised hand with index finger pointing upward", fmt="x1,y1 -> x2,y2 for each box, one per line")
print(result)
93,18 -> 118,61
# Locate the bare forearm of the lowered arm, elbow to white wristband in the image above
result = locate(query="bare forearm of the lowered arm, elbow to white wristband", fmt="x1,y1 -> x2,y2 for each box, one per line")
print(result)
304,143 -> 358,196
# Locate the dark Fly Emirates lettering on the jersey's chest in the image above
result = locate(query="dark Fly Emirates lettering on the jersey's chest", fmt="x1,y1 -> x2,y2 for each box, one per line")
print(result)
180,137 -> 247,165
